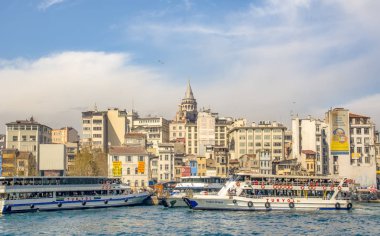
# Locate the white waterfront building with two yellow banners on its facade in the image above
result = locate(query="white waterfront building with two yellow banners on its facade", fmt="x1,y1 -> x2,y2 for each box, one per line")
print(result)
108,146 -> 151,188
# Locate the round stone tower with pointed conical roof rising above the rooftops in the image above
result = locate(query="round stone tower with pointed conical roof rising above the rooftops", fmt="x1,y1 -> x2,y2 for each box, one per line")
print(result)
176,81 -> 198,122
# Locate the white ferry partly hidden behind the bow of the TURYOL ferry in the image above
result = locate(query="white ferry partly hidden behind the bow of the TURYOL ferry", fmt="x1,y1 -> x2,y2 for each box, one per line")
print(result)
162,176 -> 225,207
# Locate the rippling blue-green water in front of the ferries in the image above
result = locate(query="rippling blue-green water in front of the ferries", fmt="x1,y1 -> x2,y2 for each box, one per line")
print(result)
0,204 -> 380,235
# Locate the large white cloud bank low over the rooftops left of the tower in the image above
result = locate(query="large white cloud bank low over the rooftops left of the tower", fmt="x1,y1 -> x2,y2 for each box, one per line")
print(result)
0,52 -> 185,133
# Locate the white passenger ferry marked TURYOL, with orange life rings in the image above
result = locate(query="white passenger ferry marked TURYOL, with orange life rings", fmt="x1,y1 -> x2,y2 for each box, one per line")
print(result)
184,173 -> 352,211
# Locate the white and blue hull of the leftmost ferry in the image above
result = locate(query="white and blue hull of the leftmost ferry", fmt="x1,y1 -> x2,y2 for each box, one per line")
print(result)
0,193 -> 150,214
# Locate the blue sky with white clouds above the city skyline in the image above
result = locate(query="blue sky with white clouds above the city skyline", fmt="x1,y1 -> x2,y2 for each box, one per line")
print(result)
0,0 -> 380,133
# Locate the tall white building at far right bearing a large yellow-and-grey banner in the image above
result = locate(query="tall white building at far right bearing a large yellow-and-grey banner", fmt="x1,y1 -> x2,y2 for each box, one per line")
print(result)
325,108 -> 376,186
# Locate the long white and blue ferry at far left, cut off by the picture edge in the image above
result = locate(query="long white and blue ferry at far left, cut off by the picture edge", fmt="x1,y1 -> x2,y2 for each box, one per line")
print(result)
0,177 -> 150,214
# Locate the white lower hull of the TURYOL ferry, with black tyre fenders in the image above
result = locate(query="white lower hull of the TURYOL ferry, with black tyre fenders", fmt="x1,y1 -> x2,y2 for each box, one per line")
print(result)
184,197 -> 352,211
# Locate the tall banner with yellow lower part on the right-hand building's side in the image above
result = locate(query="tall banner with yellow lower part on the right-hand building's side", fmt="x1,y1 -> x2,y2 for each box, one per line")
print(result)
331,110 -> 350,155
